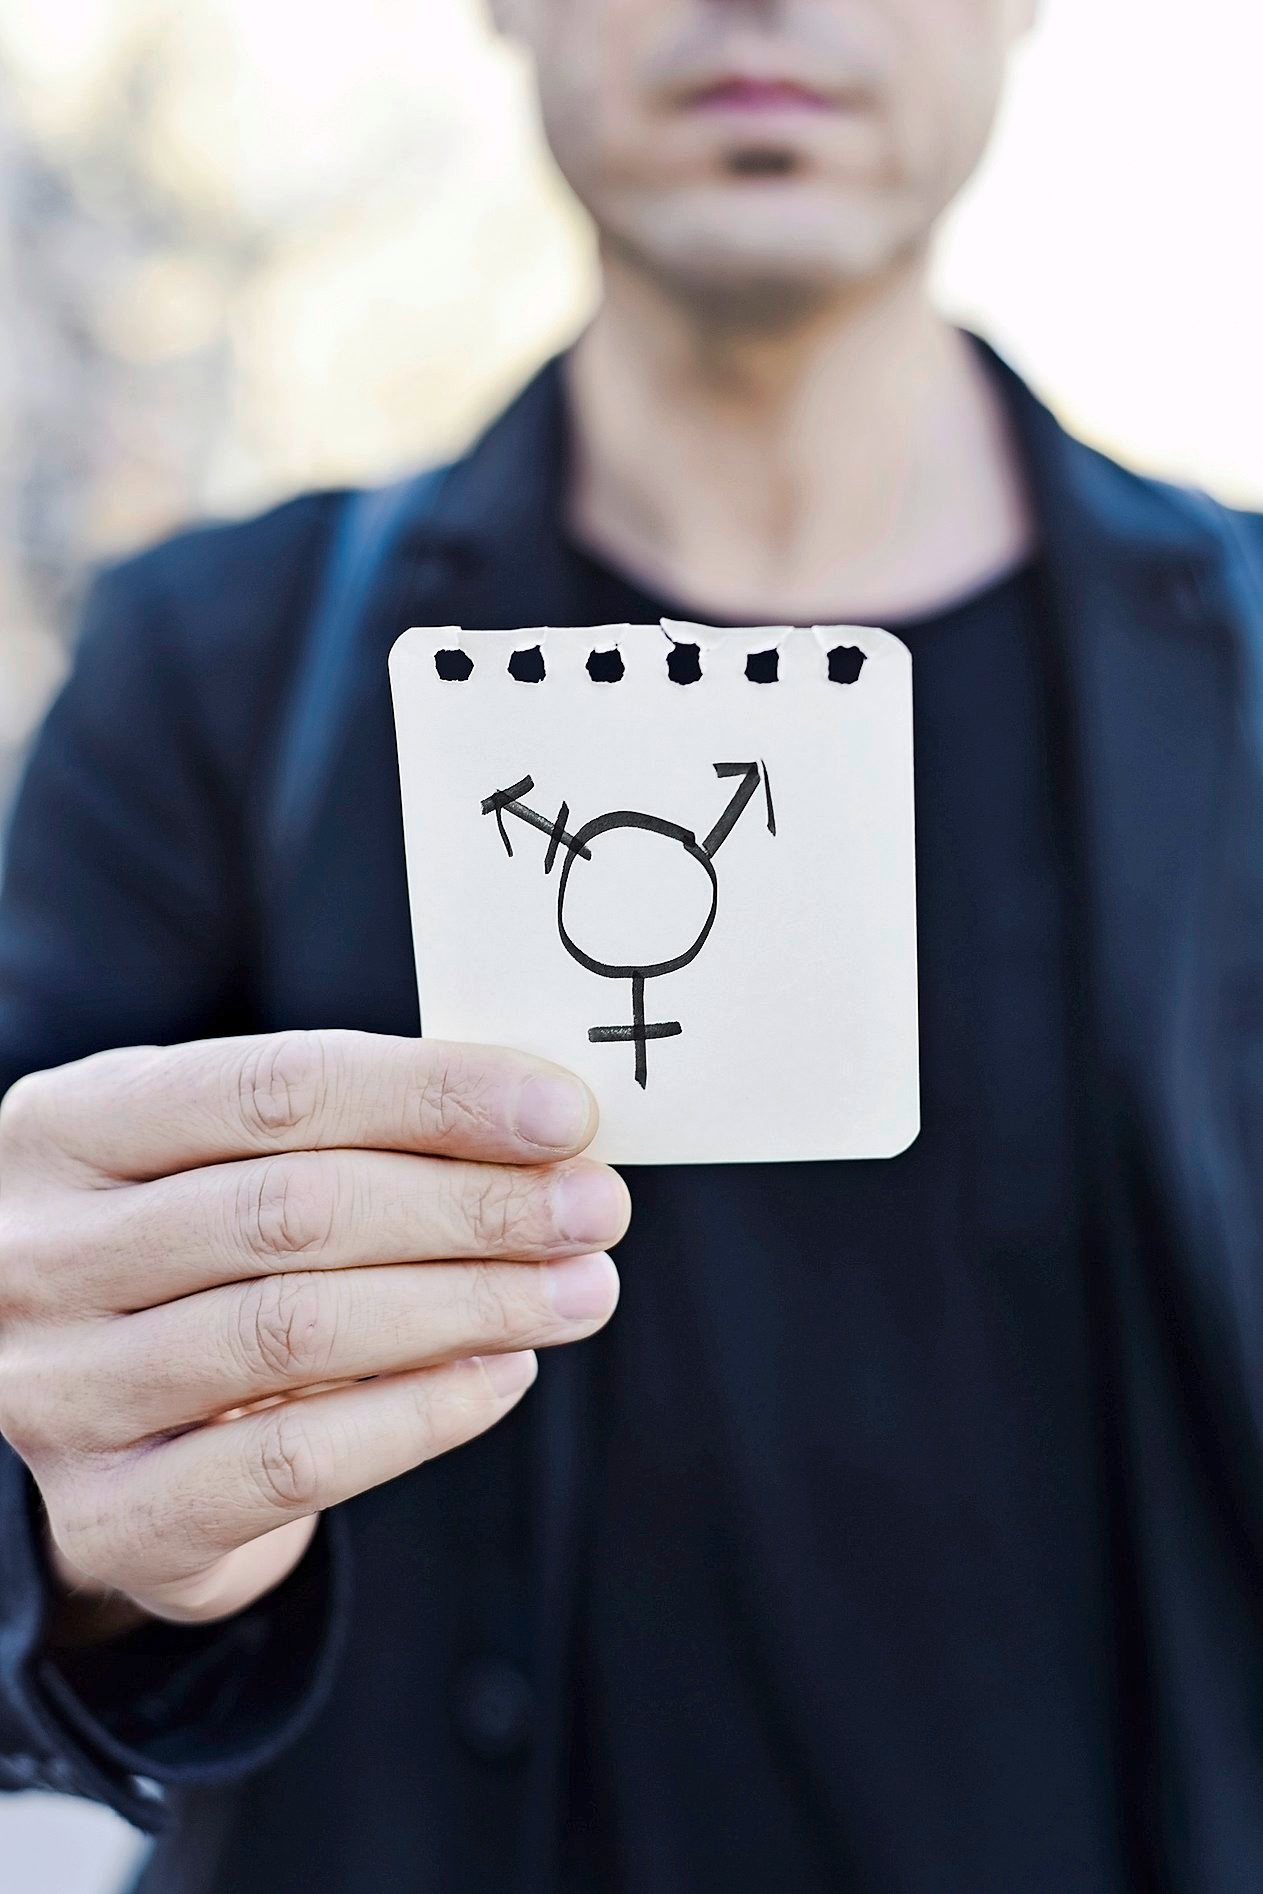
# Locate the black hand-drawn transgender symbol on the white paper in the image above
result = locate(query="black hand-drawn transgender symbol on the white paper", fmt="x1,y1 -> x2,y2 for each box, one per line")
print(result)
483,763 -> 776,1087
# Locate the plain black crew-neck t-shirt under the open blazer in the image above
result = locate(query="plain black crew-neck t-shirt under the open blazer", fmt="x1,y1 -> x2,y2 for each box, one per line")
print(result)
568,553 -> 1127,1894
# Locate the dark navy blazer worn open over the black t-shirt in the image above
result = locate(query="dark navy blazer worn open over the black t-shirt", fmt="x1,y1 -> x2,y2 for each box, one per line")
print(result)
0,344 -> 1263,1894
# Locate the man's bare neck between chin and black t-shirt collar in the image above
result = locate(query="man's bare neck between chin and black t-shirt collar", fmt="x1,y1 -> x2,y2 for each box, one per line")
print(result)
568,246 -> 1032,623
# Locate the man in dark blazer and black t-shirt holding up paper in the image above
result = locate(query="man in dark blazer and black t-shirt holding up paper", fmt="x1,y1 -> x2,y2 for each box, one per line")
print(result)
0,0 -> 1263,1894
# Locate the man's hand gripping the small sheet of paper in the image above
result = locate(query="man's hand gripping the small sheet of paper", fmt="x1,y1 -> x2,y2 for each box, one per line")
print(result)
0,1032 -> 629,1621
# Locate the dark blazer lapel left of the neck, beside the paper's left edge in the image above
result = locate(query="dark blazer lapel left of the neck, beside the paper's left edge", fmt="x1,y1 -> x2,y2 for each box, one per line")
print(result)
259,364 -> 583,1032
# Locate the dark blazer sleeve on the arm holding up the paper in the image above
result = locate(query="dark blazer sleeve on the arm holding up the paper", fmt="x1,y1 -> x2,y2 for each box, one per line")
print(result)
0,555 -> 347,1831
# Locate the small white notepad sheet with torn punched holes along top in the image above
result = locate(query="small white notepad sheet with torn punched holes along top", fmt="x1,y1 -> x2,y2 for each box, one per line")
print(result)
390,621 -> 920,1165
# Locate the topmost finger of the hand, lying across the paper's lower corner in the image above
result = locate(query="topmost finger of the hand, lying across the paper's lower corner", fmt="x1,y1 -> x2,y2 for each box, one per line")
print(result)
23,1030 -> 596,1182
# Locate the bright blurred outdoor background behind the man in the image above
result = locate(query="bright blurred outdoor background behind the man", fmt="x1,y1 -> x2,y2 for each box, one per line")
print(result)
0,0 -> 1263,1894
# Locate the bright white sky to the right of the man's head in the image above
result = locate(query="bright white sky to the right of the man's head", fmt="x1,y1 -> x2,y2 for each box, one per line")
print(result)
943,0 -> 1263,498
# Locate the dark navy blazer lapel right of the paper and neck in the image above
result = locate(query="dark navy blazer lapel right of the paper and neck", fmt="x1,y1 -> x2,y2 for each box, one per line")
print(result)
990,356 -> 1238,1095
